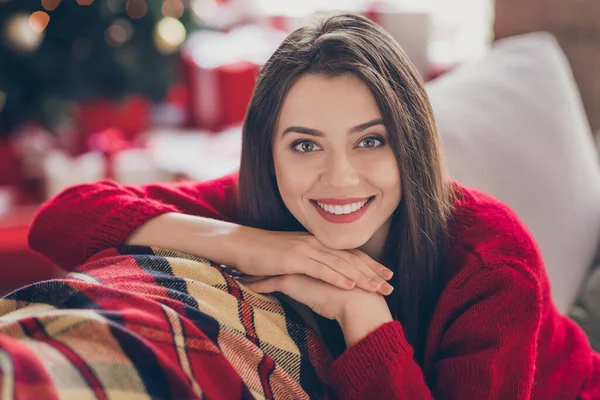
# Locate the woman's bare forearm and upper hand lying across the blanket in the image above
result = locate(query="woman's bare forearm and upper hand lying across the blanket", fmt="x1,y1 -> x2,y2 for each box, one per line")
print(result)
127,213 -> 392,295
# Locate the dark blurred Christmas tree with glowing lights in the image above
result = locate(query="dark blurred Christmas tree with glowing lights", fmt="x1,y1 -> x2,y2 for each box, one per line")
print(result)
0,0 -> 198,136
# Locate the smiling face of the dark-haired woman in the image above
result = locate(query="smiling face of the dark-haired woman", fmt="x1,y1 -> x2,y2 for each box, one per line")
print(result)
273,74 -> 402,257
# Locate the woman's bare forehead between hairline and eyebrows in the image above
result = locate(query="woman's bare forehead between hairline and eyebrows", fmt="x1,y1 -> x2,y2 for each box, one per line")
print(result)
277,74 -> 381,132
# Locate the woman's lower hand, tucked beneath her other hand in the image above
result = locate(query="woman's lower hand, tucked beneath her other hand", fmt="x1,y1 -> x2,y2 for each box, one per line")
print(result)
242,275 -> 393,347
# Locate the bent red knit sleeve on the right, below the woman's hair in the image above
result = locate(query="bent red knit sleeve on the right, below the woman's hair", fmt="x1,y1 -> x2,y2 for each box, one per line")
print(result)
330,265 -> 541,400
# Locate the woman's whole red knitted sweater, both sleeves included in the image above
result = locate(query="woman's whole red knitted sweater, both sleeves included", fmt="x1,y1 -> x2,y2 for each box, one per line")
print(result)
29,175 -> 600,400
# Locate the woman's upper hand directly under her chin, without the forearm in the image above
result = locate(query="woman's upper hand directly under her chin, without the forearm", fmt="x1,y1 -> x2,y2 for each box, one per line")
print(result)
231,227 -> 393,295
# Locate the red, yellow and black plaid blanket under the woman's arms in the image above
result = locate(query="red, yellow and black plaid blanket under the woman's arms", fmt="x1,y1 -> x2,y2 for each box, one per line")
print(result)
0,247 -> 334,400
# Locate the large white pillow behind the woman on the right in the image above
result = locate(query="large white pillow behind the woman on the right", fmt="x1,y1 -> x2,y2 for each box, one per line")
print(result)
428,33 -> 600,312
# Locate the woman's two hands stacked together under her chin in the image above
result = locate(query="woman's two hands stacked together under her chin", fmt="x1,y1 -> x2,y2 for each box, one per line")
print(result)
234,228 -> 393,347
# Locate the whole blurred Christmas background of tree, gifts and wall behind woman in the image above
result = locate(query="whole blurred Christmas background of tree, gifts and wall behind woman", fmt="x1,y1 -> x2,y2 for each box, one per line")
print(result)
0,0 -> 600,304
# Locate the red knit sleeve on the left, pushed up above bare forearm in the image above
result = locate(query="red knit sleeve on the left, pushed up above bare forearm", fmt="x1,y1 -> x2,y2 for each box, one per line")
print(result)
28,174 -> 237,271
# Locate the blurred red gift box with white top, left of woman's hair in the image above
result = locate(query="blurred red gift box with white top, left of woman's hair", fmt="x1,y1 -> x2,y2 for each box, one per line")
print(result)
182,26 -> 285,131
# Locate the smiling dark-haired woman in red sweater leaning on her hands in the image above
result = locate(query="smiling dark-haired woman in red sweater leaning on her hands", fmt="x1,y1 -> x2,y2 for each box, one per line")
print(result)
30,15 -> 600,399
